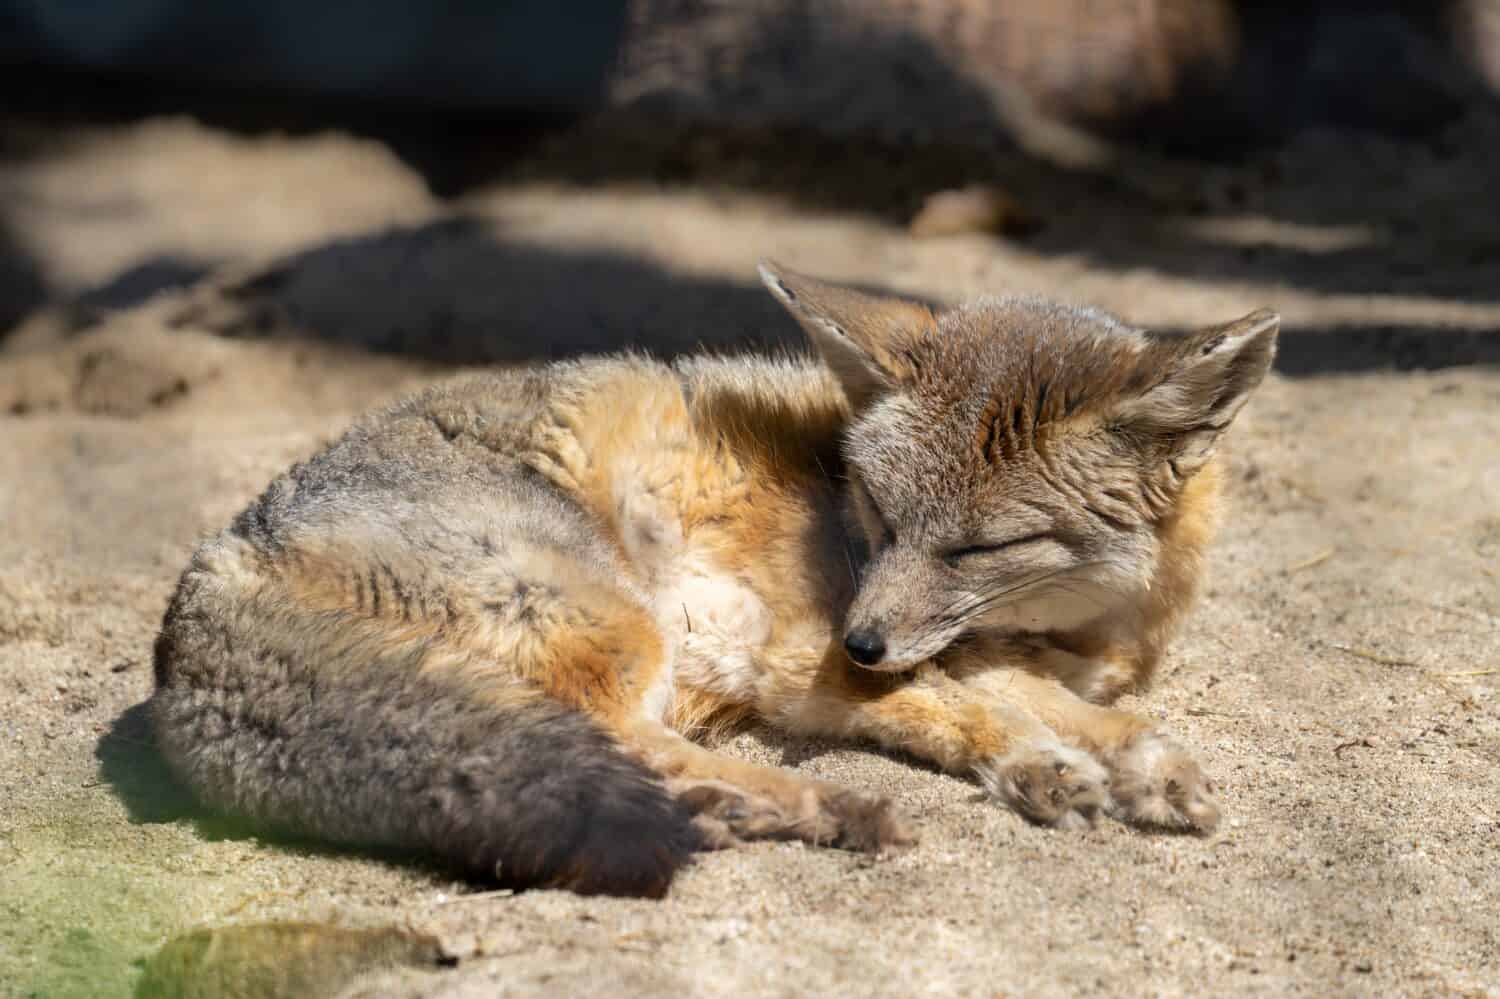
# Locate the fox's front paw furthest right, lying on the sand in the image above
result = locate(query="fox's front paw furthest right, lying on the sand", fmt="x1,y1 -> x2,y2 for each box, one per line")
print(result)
1110,732 -> 1218,833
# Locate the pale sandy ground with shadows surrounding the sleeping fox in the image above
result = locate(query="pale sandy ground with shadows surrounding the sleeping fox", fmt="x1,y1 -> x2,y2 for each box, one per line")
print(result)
0,105 -> 1500,996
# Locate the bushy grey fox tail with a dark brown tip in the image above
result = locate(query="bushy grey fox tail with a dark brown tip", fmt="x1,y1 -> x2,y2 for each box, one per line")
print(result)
152,570 -> 699,897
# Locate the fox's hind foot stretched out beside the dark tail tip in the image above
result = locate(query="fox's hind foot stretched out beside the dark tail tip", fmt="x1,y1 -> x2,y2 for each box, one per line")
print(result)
618,720 -> 915,852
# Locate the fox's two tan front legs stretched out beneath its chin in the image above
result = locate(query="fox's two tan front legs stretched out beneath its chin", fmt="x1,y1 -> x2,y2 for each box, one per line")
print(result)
762,654 -> 1218,830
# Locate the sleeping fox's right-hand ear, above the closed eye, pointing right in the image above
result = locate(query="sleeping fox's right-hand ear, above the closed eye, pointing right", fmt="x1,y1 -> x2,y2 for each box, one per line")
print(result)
1110,309 -> 1281,474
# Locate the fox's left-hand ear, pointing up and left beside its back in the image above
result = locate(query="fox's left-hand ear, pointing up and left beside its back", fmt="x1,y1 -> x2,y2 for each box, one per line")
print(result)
761,261 -> 938,410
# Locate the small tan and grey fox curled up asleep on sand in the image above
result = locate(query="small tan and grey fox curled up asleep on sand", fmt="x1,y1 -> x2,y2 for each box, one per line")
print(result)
153,264 -> 1280,896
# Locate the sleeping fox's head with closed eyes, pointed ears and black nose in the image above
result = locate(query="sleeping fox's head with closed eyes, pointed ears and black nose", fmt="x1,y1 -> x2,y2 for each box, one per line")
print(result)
761,264 -> 1280,672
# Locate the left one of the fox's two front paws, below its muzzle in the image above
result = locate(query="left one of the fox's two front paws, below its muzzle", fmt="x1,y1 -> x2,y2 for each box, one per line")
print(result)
975,741 -> 1110,830
